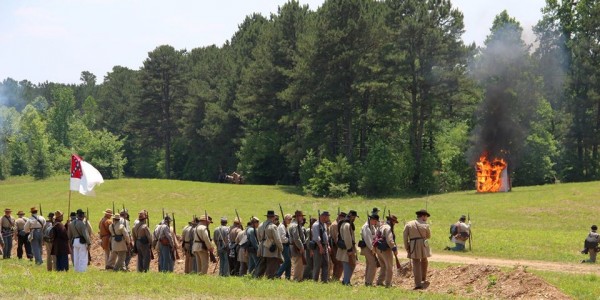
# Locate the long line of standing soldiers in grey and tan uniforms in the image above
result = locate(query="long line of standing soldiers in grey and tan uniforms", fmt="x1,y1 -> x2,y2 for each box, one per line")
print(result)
2,207 -> 431,289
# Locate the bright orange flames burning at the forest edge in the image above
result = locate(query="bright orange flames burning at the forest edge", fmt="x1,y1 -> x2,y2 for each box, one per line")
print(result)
476,152 -> 510,193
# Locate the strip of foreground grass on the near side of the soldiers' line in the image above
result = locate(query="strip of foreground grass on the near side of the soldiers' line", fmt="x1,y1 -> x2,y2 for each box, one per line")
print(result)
0,260 -> 452,299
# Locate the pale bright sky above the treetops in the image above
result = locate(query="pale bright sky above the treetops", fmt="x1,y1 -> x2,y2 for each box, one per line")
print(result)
0,0 -> 544,83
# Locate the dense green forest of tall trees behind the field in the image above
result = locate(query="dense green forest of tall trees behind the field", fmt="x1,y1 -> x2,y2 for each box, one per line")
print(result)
0,0 -> 600,196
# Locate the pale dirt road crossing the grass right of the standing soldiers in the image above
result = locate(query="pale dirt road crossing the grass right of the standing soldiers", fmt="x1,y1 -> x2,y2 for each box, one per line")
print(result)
429,253 -> 600,275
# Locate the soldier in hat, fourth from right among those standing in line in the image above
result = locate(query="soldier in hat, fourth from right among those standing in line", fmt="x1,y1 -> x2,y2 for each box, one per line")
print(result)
336,210 -> 358,285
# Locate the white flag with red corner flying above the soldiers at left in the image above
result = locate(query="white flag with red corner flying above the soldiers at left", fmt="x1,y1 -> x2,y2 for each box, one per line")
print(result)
71,154 -> 104,196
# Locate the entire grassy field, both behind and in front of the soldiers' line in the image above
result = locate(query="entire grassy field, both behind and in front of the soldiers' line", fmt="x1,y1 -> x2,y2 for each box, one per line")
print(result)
0,177 -> 600,299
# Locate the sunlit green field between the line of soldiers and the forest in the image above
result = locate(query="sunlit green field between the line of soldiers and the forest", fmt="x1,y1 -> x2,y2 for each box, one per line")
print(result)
0,177 -> 600,262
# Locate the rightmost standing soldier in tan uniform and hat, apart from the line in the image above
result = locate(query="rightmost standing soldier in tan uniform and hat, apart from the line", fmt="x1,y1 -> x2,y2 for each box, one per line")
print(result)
403,209 -> 431,290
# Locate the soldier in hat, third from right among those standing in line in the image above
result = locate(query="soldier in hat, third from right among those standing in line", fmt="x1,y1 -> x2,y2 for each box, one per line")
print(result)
359,209 -> 379,286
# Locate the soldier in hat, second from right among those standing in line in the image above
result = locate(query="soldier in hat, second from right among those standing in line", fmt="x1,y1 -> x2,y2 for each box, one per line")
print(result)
376,215 -> 398,287
